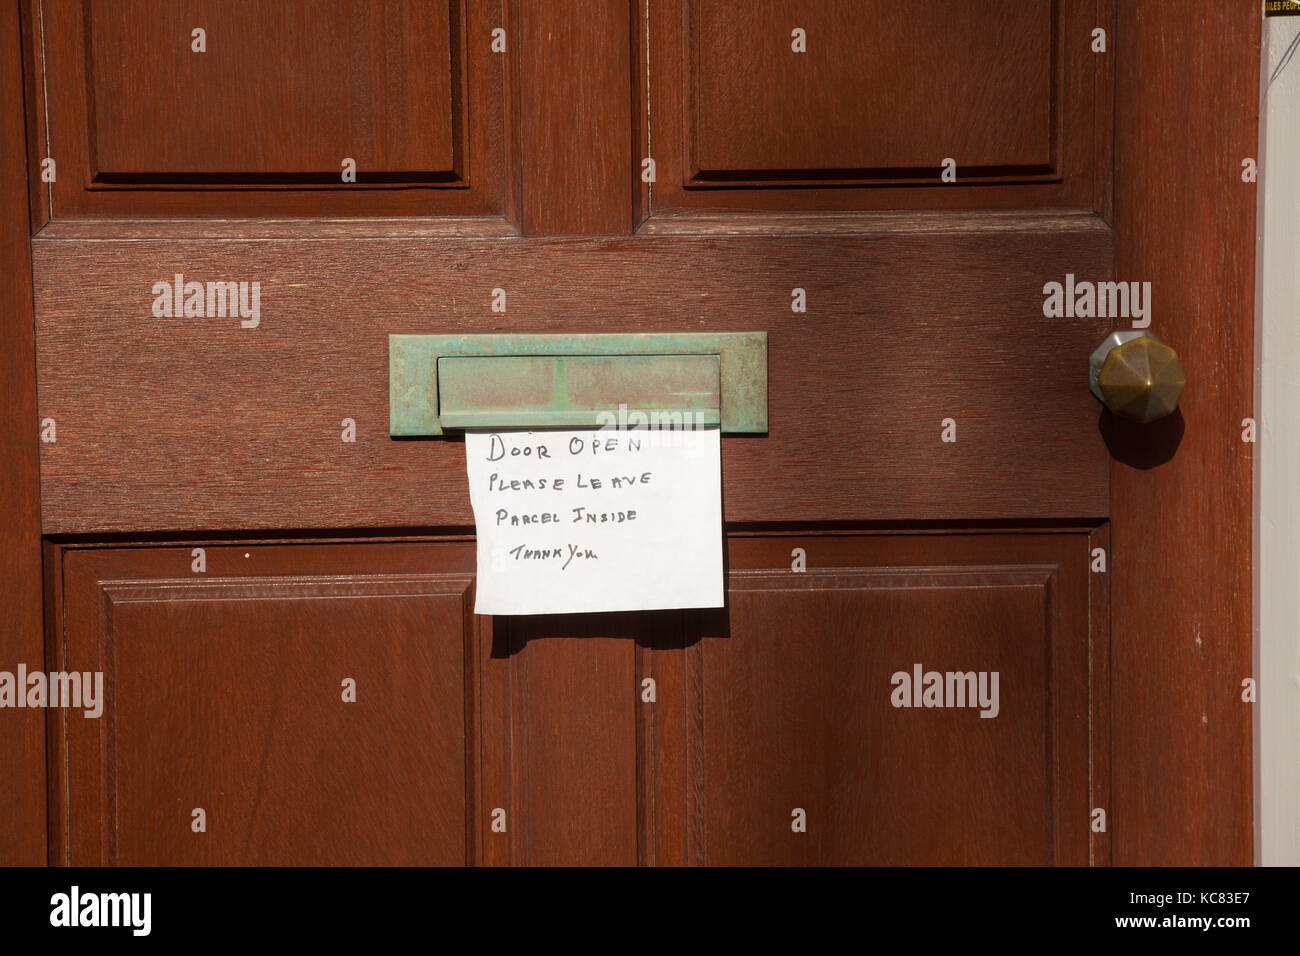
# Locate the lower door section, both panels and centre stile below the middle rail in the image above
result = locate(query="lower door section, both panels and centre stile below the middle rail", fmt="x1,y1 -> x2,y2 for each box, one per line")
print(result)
52,531 -> 1106,865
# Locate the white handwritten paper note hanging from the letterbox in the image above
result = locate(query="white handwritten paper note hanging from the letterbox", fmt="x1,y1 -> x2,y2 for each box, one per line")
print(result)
465,428 -> 723,614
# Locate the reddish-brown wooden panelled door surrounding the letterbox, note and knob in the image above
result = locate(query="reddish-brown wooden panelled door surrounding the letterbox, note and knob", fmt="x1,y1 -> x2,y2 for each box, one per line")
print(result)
0,0 -> 1258,865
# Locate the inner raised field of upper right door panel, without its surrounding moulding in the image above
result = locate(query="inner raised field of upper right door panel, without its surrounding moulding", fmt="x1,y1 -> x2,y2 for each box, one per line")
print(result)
686,0 -> 1060,182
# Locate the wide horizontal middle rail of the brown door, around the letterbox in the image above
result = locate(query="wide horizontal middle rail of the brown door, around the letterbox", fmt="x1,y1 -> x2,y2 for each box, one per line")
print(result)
34,216 -> 1110,533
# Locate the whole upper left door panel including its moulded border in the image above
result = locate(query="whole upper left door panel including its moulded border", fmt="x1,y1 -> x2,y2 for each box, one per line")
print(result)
38,0 -> 504,217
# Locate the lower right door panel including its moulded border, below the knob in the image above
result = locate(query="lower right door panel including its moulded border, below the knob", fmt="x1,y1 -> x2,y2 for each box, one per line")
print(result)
668,532 -> 1105,865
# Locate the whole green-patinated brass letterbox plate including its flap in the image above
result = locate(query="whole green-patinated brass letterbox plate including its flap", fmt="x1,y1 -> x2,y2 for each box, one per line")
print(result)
389,332 -> 767,437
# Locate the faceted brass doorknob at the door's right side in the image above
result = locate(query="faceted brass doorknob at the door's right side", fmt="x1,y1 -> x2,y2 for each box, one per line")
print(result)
1088,329 -> 1187,421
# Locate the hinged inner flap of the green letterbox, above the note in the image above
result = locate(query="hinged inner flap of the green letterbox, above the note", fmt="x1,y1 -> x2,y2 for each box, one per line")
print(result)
438,355 -> 722,428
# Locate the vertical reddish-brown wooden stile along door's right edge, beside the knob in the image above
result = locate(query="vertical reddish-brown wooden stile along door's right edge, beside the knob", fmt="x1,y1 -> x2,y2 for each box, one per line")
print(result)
1110,1 -> 1260,866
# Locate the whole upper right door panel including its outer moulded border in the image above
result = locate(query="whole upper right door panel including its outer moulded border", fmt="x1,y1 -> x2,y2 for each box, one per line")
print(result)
644,0 -> 1109,213
